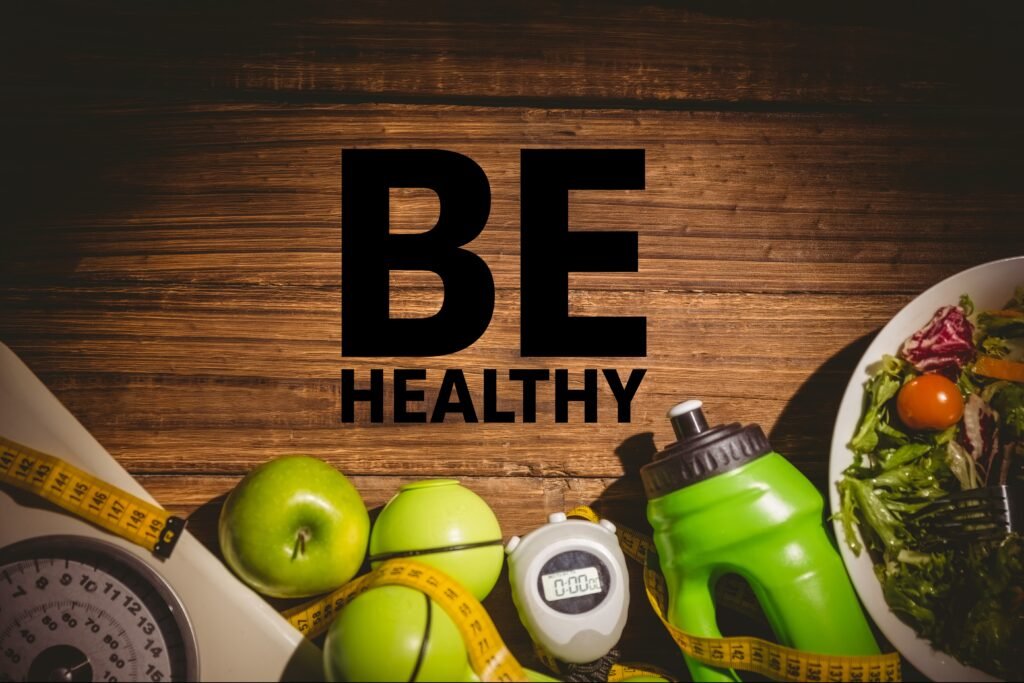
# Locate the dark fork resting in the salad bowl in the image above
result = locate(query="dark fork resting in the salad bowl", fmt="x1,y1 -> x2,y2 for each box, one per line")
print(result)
910,485 -> 1024,549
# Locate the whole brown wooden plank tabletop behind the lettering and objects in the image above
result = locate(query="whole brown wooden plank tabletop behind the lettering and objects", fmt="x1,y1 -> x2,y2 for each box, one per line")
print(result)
0,1 -> 1024,671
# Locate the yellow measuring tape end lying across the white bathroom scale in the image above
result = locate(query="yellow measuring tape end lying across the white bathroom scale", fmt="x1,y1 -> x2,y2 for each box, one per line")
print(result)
0,436 -> 185,558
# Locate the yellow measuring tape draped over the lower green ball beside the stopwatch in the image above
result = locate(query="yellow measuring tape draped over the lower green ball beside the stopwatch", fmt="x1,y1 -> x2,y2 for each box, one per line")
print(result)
284,559 -> 528,681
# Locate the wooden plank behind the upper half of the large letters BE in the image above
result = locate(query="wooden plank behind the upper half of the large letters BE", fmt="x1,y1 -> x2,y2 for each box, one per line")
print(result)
0,104 -> 1024,292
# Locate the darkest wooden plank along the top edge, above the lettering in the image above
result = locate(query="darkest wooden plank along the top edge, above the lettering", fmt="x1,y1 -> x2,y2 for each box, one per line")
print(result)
3,0 -> 1022,106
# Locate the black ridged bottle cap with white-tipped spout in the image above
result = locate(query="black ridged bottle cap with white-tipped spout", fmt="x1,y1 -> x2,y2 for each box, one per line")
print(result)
640,400 -> 771,499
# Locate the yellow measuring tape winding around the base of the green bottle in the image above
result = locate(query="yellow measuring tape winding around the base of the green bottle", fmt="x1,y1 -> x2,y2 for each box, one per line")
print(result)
566,506 -> 902,682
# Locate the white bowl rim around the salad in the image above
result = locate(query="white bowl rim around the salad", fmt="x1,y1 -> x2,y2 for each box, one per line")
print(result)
828,256 -> 1024,681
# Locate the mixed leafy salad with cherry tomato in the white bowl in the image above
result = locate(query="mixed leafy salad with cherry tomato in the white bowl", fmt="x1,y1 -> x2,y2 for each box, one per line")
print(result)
837,287 -> 1024,680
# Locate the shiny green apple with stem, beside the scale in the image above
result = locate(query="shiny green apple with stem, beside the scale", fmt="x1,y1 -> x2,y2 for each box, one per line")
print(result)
218,456 -> 370,598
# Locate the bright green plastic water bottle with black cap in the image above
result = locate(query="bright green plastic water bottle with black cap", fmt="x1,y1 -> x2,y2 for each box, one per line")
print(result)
641,400 -> 879,681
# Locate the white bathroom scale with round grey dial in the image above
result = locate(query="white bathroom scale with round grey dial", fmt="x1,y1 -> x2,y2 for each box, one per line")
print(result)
0,343 -> 324,682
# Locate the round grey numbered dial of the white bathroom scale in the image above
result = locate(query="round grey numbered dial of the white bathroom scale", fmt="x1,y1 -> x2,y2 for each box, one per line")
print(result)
0,536 -> 199,682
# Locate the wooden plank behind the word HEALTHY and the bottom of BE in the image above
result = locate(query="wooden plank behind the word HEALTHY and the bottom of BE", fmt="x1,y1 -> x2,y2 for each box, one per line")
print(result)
6,288 -> 907,476
